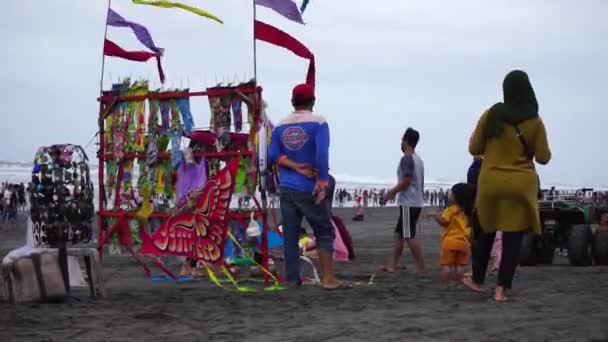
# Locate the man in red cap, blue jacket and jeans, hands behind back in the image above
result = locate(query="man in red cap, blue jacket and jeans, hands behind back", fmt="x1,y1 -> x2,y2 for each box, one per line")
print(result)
269,84 -> 344,290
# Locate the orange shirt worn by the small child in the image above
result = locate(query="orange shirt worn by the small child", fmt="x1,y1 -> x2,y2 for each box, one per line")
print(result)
441,204 -> 471,250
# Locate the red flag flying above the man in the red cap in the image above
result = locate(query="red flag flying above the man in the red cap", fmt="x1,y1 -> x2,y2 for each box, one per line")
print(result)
254,20 -> 315,87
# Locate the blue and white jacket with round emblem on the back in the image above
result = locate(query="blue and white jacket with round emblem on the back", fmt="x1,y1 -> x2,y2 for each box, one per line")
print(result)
268,111 -> 329,192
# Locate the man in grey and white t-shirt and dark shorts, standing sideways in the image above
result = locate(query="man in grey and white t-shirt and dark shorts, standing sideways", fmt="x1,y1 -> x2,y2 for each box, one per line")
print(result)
384,128 -> 425,273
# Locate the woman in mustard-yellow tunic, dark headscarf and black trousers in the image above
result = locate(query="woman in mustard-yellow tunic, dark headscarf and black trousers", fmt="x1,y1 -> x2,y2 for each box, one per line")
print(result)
464,70 -> 551,301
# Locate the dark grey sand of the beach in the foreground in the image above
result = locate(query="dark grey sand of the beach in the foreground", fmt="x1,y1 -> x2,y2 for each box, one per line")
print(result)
0,208 -> 608,342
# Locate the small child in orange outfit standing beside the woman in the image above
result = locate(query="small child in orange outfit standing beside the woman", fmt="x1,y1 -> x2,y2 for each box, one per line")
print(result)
434,183 -> 475,288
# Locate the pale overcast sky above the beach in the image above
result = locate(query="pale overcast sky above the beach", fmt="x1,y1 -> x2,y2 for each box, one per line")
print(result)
0,0 -> 608,185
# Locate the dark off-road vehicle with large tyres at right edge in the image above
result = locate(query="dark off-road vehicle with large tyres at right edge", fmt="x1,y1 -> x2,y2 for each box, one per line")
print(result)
520,189 -> 608,266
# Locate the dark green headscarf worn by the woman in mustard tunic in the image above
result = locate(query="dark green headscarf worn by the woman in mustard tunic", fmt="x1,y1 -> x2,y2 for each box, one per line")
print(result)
485,70 -> 538,139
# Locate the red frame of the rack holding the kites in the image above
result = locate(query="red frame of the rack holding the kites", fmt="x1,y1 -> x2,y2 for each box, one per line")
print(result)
97,83 -> 271,285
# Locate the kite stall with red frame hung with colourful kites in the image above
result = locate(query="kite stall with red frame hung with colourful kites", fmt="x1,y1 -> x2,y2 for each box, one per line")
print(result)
98,80 -> 284,292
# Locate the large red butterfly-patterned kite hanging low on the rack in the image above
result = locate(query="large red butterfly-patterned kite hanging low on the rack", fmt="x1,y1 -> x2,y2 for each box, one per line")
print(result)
139,158 -> 239,265
